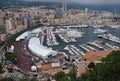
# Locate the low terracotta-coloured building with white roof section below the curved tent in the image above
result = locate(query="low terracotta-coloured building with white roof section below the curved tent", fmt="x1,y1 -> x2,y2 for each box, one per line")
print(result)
37,63 -> 62,75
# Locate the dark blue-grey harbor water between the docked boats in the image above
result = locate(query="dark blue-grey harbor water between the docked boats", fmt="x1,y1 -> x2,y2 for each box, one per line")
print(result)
43,27 -> 120,54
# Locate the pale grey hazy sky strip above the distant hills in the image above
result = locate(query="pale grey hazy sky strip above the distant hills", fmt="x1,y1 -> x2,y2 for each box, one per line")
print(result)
27,0 -> 120,4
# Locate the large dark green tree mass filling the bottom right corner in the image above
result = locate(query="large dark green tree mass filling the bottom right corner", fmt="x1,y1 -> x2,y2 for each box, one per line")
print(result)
81,51 -> 120,81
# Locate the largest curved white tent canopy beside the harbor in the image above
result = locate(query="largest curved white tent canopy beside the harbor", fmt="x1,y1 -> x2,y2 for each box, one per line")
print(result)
28,37 -> 57,58
